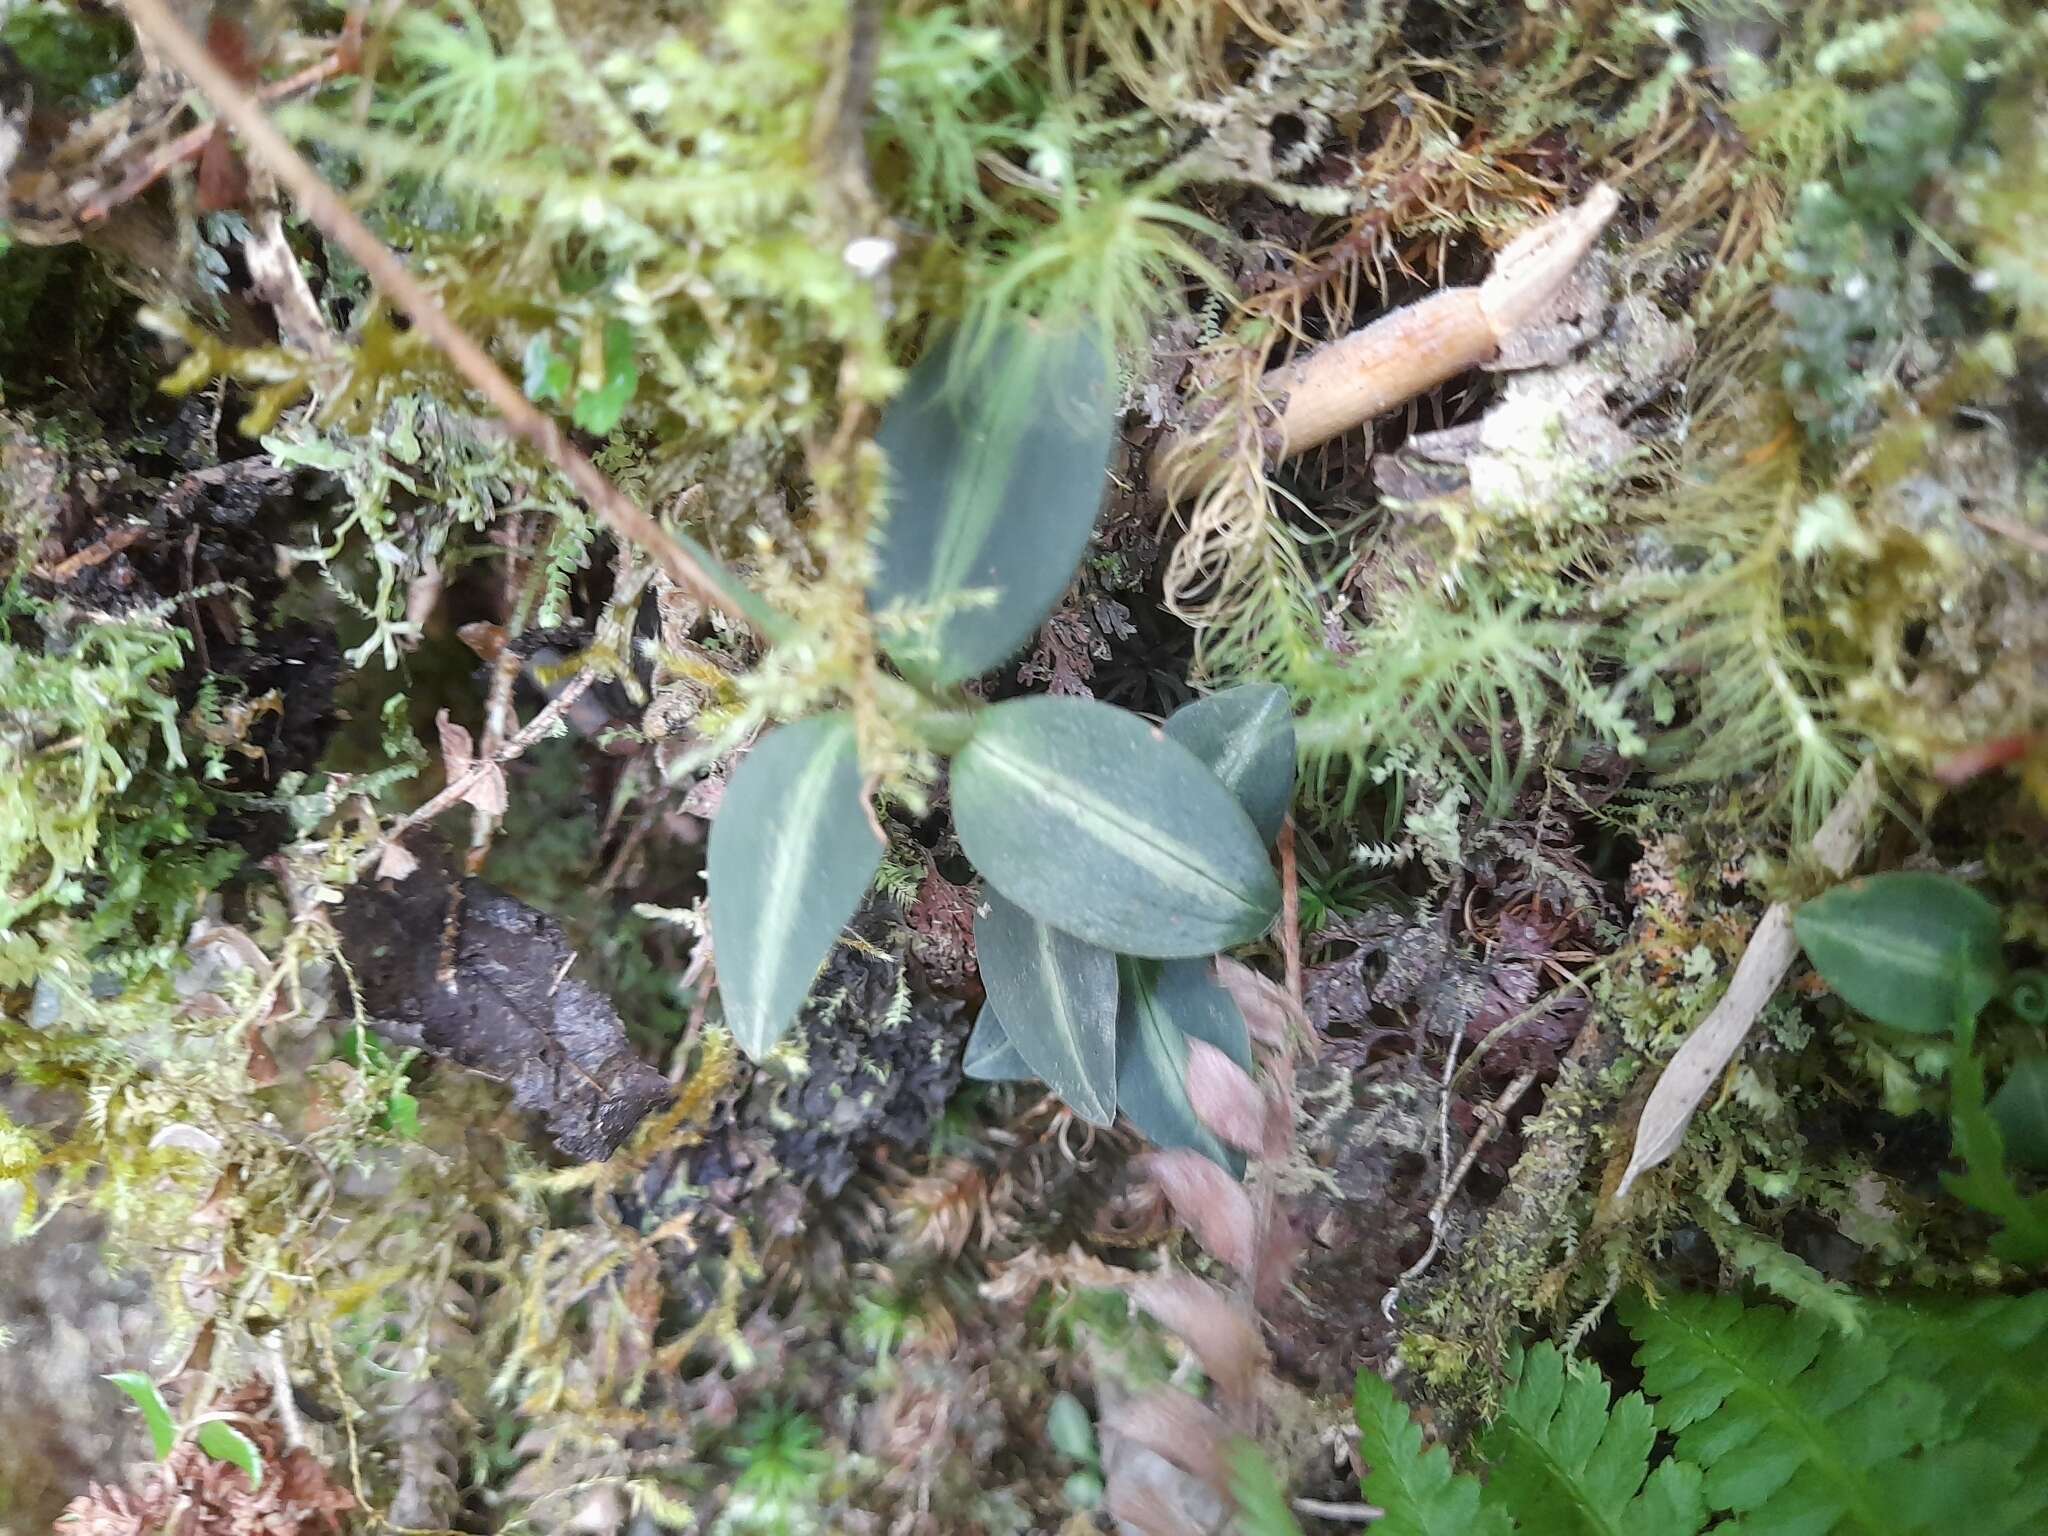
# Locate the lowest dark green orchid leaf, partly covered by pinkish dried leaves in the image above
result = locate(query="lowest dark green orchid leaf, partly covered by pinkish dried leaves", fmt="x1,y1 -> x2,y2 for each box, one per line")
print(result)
1116,956 -> 1251,1174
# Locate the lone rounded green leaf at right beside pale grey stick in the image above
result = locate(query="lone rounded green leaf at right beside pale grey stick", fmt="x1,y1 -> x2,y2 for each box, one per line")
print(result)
1792,870 -> 2005,1034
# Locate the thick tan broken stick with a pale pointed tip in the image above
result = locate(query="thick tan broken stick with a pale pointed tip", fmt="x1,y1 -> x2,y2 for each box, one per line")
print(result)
1153,182 -> 1620,489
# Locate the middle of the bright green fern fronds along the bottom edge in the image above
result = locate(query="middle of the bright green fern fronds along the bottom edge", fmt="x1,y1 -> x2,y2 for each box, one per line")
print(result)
1479,1343 -> 1706,1536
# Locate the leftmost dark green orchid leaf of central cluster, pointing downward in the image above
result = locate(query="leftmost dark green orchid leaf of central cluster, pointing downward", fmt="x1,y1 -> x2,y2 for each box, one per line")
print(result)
709,715 -> 883,1061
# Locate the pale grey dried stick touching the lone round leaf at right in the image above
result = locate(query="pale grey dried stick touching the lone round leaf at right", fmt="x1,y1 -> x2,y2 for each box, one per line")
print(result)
1614,762 -> 1878,1202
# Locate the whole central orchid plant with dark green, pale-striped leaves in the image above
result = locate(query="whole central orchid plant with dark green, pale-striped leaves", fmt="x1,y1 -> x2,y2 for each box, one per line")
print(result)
709,322 -> 1294,1167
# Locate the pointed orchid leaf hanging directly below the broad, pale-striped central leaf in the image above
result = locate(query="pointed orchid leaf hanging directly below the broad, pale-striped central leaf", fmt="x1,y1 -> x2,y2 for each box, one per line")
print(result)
975,891 -> 1116,1126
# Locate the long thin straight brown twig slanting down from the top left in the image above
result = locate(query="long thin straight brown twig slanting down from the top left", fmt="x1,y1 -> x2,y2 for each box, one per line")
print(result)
123,0 -> 752,629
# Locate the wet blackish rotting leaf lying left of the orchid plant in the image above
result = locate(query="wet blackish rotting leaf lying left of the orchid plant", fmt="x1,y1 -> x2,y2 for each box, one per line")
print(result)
334,834 -> 670,1161
